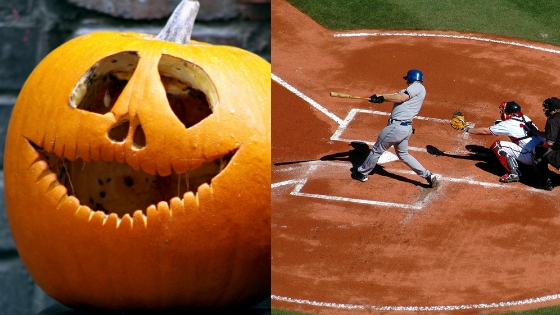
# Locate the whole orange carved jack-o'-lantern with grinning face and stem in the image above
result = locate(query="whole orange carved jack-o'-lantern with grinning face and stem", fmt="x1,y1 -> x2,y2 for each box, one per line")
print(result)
4,1 -> 271,310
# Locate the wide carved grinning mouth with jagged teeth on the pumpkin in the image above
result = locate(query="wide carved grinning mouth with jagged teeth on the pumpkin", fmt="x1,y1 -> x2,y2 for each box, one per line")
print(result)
29,141 -> 235,217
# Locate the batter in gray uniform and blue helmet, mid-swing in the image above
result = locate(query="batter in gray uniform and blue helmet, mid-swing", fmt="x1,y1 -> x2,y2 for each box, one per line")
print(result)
352,69 -> 437,188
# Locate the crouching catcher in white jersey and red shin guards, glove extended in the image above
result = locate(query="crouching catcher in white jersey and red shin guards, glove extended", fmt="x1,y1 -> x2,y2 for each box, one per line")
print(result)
451,101 -> 544,183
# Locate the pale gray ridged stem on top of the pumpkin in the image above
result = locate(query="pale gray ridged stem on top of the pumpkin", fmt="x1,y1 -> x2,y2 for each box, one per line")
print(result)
156,0 -> 200,45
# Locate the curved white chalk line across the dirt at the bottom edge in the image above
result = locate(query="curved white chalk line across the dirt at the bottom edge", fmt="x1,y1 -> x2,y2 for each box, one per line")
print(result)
271,294 -> 560,312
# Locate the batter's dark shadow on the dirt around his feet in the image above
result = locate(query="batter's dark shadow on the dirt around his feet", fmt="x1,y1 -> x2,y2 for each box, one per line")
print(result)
321,141 -> 428,187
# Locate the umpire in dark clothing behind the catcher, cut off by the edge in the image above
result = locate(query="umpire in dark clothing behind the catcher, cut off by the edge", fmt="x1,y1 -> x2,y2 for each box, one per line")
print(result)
533,97 -> 560,190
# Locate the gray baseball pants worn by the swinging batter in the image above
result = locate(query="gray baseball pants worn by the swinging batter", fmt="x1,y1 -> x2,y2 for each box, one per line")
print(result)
358,121 -> 431,178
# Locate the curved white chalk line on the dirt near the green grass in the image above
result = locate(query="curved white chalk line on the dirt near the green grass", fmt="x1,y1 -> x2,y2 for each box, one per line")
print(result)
334,32 -> 560,54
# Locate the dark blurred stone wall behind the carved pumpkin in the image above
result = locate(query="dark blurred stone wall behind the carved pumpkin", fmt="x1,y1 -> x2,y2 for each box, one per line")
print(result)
0,0 -> 270,315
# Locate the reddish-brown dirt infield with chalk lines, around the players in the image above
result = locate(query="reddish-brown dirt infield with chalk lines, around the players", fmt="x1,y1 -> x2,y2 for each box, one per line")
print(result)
272,0 -> 560,314
